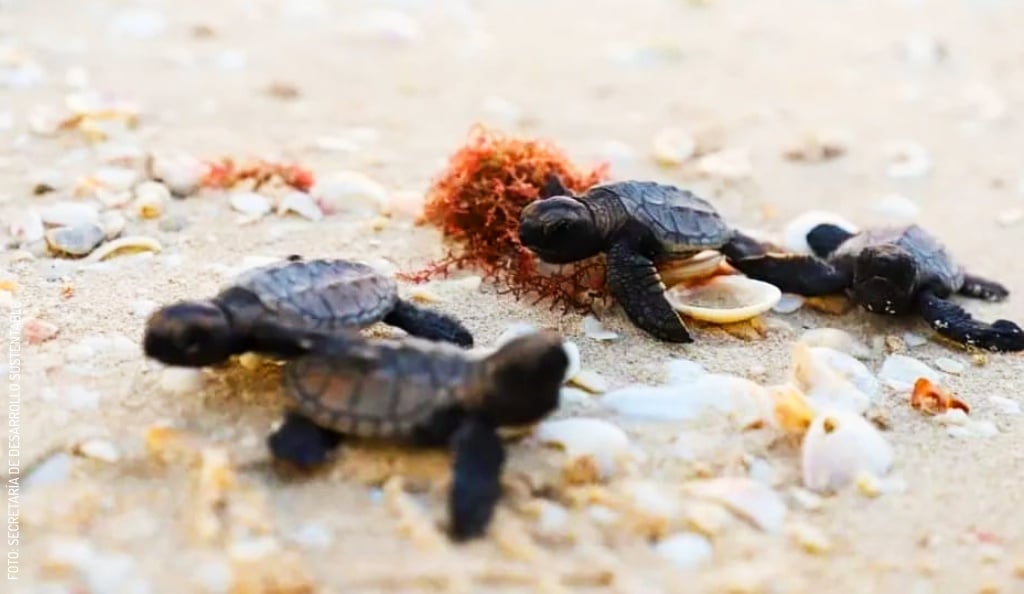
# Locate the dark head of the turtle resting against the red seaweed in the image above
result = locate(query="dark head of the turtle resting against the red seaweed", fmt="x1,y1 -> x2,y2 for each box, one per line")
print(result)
519,196 -> 602,264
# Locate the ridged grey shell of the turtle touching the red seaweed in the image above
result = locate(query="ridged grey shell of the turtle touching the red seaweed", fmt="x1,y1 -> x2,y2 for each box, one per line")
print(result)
587,181 -> 730,252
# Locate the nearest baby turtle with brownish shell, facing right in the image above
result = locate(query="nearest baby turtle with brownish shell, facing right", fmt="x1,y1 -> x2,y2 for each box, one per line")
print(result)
267,331 -> 569,540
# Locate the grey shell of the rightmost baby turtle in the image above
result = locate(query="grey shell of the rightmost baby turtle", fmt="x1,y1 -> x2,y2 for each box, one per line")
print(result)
834,224 -> 964,291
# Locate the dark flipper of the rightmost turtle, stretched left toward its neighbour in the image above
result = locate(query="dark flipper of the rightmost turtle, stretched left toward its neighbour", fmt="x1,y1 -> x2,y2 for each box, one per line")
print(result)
726,253 -> 851,297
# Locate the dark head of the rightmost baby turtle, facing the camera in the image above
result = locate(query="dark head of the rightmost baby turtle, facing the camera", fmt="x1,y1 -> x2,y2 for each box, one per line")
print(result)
851,246 -> 919,314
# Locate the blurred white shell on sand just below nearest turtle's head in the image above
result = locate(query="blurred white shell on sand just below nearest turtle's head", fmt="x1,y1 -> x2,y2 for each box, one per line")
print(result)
535,417 -> 631,479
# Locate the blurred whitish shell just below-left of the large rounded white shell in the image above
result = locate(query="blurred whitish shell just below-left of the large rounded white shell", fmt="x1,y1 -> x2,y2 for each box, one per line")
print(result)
684,477 -> 787,533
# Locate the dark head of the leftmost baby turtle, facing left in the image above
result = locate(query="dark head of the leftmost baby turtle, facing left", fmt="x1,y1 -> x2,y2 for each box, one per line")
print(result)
142,301 -> 238,367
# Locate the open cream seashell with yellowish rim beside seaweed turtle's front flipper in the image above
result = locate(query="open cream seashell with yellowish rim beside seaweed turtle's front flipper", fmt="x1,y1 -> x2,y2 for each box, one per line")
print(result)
666,275 -> 782,324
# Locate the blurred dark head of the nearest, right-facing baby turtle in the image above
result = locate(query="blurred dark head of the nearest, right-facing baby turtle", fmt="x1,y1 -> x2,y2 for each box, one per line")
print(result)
482,331 -> 569,426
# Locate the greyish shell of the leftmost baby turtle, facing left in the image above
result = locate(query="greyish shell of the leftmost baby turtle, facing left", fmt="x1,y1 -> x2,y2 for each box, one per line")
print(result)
221,259 -> 398,331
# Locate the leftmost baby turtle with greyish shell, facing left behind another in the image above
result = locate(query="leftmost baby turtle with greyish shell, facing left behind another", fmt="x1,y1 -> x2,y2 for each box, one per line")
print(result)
143,256 -> 473,367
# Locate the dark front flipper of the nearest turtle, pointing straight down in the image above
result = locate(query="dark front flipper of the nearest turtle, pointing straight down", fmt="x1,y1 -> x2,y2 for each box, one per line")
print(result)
449,415 -> 505,541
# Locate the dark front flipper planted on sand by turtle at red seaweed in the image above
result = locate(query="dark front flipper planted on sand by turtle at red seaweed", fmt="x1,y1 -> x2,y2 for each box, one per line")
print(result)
606,242 -> 693,342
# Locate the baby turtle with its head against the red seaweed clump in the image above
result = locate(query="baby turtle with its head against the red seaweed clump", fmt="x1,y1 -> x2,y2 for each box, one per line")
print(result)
519,176 -> 732,342
